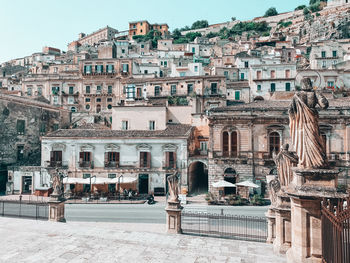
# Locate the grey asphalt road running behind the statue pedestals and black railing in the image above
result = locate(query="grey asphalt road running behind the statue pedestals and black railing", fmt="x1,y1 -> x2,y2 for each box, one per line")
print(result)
65,203 -> 267,224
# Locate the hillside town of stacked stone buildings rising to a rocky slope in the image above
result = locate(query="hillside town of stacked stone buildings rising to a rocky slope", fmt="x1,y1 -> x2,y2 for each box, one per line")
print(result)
0,1 -> 350,202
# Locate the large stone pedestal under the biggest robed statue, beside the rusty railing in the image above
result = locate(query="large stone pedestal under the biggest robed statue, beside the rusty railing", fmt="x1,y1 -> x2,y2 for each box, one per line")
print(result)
287,168 -> 344,263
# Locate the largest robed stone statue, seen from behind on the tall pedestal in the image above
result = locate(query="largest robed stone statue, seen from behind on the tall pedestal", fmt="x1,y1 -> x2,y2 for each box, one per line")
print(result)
289,78 -> 328,169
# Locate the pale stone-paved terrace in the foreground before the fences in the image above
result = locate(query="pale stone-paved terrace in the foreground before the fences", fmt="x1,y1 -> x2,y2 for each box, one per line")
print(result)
0,217 -> 285,263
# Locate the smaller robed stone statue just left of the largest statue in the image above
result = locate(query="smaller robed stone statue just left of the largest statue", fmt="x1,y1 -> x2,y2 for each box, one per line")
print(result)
274,143 -> 298,186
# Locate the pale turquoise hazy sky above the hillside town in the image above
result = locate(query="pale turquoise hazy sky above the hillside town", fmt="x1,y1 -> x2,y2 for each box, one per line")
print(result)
0,0 -> 309,63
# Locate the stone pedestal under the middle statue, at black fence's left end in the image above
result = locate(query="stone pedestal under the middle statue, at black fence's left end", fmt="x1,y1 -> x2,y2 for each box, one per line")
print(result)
165,201 -> 182,234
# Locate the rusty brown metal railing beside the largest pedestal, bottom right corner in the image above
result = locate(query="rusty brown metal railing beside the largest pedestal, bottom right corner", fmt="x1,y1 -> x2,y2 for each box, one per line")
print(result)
321,198 -> 350,263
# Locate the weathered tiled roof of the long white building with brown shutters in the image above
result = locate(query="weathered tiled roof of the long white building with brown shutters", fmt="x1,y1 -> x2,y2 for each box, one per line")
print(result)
43,124 -> 193,138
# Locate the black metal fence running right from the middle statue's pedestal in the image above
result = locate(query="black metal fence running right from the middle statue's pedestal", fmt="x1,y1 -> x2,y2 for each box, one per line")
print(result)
181,212 -> 267,242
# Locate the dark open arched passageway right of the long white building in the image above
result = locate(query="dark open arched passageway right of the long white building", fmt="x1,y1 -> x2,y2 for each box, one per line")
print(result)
188,161 -> 208,194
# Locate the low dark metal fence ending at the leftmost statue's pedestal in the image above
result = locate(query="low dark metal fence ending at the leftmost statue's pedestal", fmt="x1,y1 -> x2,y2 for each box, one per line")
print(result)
0,201 -> 49,220
